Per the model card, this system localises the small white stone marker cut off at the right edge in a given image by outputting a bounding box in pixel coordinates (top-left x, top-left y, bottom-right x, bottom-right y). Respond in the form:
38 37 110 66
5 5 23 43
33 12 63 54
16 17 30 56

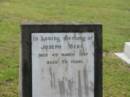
115 42 130 64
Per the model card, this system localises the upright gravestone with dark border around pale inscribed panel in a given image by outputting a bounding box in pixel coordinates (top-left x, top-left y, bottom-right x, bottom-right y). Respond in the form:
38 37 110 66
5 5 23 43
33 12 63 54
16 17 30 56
21 24 102 97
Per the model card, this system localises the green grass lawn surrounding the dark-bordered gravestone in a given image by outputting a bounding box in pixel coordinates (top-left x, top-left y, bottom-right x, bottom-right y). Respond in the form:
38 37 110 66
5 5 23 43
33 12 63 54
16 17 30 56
0 0 130 97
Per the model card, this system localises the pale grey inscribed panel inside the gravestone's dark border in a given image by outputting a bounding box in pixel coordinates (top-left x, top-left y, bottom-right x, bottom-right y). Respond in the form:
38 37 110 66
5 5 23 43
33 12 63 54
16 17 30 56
31 32 94 97
